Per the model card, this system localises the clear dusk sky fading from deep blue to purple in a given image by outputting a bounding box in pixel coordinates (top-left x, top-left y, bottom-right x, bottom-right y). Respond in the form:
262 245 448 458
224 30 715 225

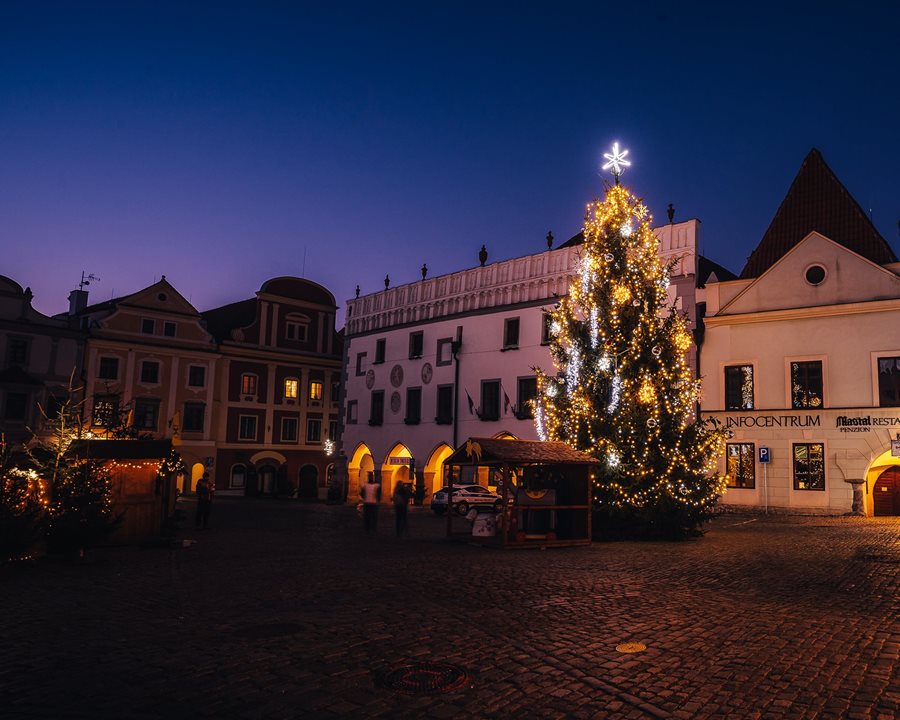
0 0 900 324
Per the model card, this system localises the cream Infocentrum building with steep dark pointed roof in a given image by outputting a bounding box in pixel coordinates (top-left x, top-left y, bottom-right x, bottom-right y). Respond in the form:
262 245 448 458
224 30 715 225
700 150 900 516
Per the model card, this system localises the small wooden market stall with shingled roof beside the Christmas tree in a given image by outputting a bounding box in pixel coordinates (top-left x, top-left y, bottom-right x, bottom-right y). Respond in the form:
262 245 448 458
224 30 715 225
444 438 599 548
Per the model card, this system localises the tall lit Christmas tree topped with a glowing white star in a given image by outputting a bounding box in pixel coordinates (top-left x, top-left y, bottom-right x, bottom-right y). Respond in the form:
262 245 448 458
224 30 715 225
535 146 725 537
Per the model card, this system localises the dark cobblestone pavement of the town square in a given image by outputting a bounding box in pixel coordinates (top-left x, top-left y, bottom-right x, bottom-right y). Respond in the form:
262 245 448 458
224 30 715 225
0 499 900 720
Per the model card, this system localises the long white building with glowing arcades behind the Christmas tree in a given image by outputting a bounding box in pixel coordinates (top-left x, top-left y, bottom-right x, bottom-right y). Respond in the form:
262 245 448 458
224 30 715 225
342 220 729 502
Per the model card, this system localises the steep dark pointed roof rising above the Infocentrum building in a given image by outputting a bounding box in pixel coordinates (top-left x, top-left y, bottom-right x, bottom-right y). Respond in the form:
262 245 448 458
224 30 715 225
741 148 897 278
